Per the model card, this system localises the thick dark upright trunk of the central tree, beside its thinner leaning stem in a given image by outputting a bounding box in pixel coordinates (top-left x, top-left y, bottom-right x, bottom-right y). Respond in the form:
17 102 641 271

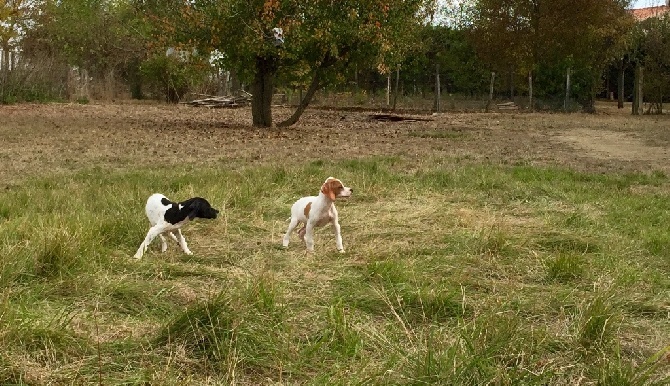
251 56 276 127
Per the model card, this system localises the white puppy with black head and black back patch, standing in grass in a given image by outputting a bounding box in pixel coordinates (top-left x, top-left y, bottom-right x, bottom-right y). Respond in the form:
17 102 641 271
135 193 219 259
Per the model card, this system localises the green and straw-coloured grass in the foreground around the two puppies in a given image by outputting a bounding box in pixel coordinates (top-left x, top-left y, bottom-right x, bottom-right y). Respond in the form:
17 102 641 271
0 159 670 385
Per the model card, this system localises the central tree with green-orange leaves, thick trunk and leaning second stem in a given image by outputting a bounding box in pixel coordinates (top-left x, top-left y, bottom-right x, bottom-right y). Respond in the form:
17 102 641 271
161 0 434 127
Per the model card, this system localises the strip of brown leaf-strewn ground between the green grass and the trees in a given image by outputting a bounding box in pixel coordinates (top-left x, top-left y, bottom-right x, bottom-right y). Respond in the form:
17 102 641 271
0 104 670 182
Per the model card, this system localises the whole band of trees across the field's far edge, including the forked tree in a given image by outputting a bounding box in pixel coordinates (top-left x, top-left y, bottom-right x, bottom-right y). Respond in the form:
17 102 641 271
0 0 670 126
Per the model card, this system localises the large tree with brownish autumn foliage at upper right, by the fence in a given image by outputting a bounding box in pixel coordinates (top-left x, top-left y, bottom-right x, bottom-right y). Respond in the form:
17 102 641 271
469 0 632 111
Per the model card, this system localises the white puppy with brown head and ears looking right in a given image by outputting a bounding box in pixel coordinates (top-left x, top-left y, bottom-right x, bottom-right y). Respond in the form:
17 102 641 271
283 177 354 252
